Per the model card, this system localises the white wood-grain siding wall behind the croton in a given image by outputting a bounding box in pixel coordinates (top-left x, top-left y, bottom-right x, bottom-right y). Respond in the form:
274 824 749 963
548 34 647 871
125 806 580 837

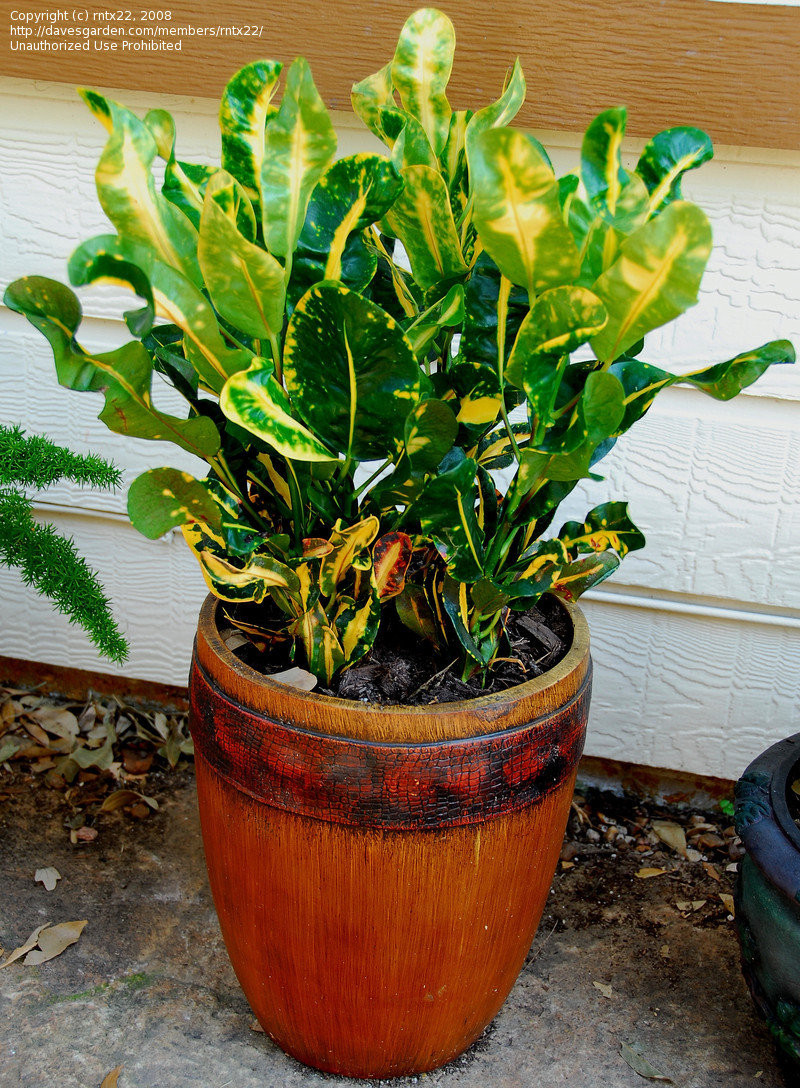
0 79 800 777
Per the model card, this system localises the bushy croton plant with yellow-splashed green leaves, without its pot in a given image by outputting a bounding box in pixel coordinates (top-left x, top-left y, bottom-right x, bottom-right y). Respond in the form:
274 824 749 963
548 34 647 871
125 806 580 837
5 9 793 681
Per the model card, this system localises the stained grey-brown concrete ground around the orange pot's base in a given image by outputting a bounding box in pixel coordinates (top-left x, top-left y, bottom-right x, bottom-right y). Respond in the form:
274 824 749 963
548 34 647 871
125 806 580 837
0 765 784 1088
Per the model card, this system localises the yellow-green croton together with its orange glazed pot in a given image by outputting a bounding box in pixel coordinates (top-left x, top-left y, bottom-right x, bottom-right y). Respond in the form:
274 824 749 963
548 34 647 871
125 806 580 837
5 9 793 1076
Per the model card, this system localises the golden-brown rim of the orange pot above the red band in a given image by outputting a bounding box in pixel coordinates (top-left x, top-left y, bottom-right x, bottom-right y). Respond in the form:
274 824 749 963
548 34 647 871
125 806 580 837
199 593 590 718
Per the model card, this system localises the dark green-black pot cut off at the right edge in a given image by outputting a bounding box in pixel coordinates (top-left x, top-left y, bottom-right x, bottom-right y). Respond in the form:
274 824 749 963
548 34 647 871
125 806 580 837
736 733 800 1072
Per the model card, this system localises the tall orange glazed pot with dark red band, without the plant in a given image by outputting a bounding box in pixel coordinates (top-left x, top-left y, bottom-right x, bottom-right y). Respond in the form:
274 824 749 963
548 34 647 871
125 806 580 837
190 597 591 1077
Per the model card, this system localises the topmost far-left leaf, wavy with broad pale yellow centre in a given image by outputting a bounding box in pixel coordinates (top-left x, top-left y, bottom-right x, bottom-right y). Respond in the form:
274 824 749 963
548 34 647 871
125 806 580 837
78 88 201 284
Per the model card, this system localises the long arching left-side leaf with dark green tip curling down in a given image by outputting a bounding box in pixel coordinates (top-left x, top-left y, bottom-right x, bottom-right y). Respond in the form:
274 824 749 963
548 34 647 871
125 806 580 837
69 235 253 393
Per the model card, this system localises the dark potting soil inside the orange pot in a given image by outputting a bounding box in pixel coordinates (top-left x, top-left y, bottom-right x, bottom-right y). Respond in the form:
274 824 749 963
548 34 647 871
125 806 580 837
226 596 571 706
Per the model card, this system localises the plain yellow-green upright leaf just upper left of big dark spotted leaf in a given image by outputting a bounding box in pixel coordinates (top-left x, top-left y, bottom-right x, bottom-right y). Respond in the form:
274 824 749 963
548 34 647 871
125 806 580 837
197 170 285 344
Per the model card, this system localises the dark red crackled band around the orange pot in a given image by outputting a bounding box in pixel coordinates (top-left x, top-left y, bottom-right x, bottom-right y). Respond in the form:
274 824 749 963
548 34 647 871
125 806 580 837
189 662 591 829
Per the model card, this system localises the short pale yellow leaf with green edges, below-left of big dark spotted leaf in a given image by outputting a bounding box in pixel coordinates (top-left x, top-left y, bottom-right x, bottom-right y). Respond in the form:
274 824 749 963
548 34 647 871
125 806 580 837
220 358 336 461
